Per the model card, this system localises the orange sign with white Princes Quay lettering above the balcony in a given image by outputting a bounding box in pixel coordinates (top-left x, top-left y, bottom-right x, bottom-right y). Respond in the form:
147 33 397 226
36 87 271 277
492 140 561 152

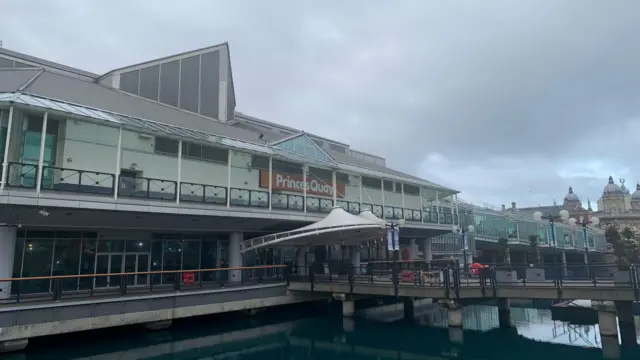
260 170 347 198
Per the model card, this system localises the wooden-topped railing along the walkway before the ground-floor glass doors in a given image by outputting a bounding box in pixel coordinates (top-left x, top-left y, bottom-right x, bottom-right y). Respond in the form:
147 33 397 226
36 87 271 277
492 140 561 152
0 265 291 304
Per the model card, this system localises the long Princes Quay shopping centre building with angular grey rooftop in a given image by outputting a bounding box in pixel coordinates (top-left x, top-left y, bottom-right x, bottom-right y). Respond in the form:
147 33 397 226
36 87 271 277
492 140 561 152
0 44 604 297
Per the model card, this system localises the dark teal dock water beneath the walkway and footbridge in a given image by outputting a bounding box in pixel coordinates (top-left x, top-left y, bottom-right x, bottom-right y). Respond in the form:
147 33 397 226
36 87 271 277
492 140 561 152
0 306 640 360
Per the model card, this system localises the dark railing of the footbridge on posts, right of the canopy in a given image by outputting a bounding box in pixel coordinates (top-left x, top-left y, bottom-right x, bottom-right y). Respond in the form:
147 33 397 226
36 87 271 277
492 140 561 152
291 261 640 301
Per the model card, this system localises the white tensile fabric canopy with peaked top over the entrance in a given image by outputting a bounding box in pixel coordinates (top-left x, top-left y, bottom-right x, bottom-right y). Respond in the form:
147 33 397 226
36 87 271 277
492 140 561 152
242 206 385 252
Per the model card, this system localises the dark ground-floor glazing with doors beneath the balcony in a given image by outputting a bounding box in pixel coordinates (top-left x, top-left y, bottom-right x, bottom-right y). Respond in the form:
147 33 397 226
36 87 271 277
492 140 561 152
12 230 295 294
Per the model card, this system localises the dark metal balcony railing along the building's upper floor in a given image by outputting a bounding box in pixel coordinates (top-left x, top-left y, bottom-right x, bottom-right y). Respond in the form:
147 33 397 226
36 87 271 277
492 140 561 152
6 162 457 224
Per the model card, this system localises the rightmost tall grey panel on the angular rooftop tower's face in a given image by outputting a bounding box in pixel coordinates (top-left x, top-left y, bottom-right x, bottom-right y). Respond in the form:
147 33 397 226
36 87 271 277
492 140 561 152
200 51 220 120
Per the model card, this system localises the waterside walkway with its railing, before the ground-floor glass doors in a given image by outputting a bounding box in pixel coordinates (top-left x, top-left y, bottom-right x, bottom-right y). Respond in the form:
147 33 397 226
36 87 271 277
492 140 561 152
0 265 328 352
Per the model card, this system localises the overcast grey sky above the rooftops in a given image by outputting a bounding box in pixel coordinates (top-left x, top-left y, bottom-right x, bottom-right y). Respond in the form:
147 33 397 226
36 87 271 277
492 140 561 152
0 0 640 205
